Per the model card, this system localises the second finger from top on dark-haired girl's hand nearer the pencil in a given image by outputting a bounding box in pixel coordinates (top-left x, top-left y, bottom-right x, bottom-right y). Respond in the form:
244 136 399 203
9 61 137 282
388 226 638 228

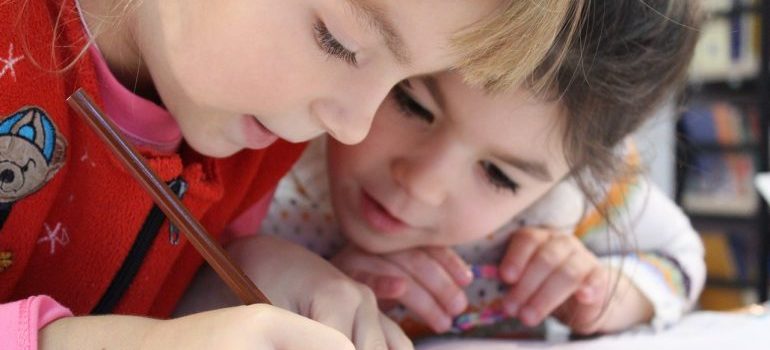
391 250 468 315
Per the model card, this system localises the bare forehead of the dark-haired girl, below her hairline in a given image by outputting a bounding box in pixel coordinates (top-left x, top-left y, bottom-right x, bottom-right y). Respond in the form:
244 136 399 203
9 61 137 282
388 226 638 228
434 72 566 171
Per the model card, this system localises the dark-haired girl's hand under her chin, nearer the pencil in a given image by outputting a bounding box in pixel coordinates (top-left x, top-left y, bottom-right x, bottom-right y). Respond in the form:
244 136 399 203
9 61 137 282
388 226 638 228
332 245 472 333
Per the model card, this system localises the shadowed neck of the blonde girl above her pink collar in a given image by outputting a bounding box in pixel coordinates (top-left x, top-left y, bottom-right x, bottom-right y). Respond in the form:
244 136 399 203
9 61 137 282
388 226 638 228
78 0 160 102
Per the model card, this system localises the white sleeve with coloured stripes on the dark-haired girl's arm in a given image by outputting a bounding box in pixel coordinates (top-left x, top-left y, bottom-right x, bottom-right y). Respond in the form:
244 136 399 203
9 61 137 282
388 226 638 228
583 176 706 329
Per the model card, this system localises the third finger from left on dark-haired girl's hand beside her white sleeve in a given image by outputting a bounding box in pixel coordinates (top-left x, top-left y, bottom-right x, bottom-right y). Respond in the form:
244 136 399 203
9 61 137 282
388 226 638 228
519 249 596 326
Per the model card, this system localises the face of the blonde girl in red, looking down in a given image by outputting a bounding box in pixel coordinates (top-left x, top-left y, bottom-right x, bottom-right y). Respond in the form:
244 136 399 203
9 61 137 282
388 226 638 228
138 0 499 156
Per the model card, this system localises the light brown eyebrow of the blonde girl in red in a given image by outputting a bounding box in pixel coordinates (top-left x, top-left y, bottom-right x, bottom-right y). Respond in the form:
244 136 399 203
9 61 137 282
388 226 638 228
347 0 411 65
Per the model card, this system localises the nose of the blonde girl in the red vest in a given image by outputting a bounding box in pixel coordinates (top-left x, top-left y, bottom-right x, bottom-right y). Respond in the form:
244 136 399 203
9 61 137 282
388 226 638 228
310 81 393 145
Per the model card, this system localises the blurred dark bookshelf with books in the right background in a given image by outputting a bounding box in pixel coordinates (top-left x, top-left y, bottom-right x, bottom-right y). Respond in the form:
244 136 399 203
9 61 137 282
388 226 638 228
675 0 770 301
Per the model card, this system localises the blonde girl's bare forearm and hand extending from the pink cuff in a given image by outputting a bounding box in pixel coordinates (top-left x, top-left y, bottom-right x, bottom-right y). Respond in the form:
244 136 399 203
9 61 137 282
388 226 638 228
39 305 354 350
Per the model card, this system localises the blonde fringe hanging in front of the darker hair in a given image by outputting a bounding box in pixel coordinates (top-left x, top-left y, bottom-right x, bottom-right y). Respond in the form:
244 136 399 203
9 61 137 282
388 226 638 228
453 0 586 92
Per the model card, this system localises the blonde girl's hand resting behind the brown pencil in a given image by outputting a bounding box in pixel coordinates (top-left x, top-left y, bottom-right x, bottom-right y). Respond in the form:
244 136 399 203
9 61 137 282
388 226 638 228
228 236 413 350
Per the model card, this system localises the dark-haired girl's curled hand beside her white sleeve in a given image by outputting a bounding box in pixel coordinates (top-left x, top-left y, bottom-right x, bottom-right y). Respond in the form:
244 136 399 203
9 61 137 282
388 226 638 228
500 228 609 330
